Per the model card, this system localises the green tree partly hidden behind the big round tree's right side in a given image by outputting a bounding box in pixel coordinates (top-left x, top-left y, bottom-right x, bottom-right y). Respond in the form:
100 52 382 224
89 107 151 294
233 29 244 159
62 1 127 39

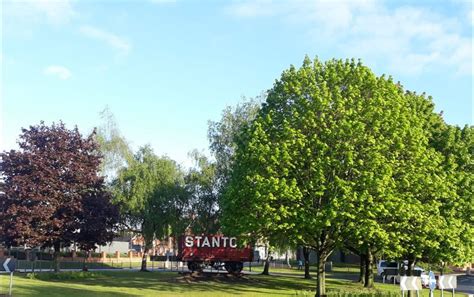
344 91 460 287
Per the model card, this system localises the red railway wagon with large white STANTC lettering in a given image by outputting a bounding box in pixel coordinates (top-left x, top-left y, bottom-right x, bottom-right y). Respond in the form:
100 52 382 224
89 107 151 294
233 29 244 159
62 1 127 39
178 235 253 273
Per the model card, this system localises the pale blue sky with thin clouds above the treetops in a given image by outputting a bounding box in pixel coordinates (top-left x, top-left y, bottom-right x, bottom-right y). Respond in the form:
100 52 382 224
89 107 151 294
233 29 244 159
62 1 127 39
0 0 474 165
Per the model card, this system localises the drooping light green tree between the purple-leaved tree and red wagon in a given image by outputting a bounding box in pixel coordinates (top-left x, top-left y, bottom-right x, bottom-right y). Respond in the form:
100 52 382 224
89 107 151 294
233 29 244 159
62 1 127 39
112 146 187 271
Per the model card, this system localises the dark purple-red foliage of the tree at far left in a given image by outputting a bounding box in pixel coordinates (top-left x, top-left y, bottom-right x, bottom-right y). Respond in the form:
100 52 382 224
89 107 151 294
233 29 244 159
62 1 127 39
0 122 119 249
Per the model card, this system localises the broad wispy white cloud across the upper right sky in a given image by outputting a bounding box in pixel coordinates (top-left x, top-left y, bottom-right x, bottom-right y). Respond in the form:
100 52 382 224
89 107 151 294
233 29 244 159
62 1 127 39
226 0 473 75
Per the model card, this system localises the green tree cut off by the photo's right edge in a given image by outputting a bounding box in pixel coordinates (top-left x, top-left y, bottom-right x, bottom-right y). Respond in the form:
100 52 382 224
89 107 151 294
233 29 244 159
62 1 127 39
414 104 474 267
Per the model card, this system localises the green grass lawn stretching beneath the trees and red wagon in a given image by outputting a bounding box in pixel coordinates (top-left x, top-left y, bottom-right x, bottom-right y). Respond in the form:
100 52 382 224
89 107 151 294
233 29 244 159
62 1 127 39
0 269 465 297
